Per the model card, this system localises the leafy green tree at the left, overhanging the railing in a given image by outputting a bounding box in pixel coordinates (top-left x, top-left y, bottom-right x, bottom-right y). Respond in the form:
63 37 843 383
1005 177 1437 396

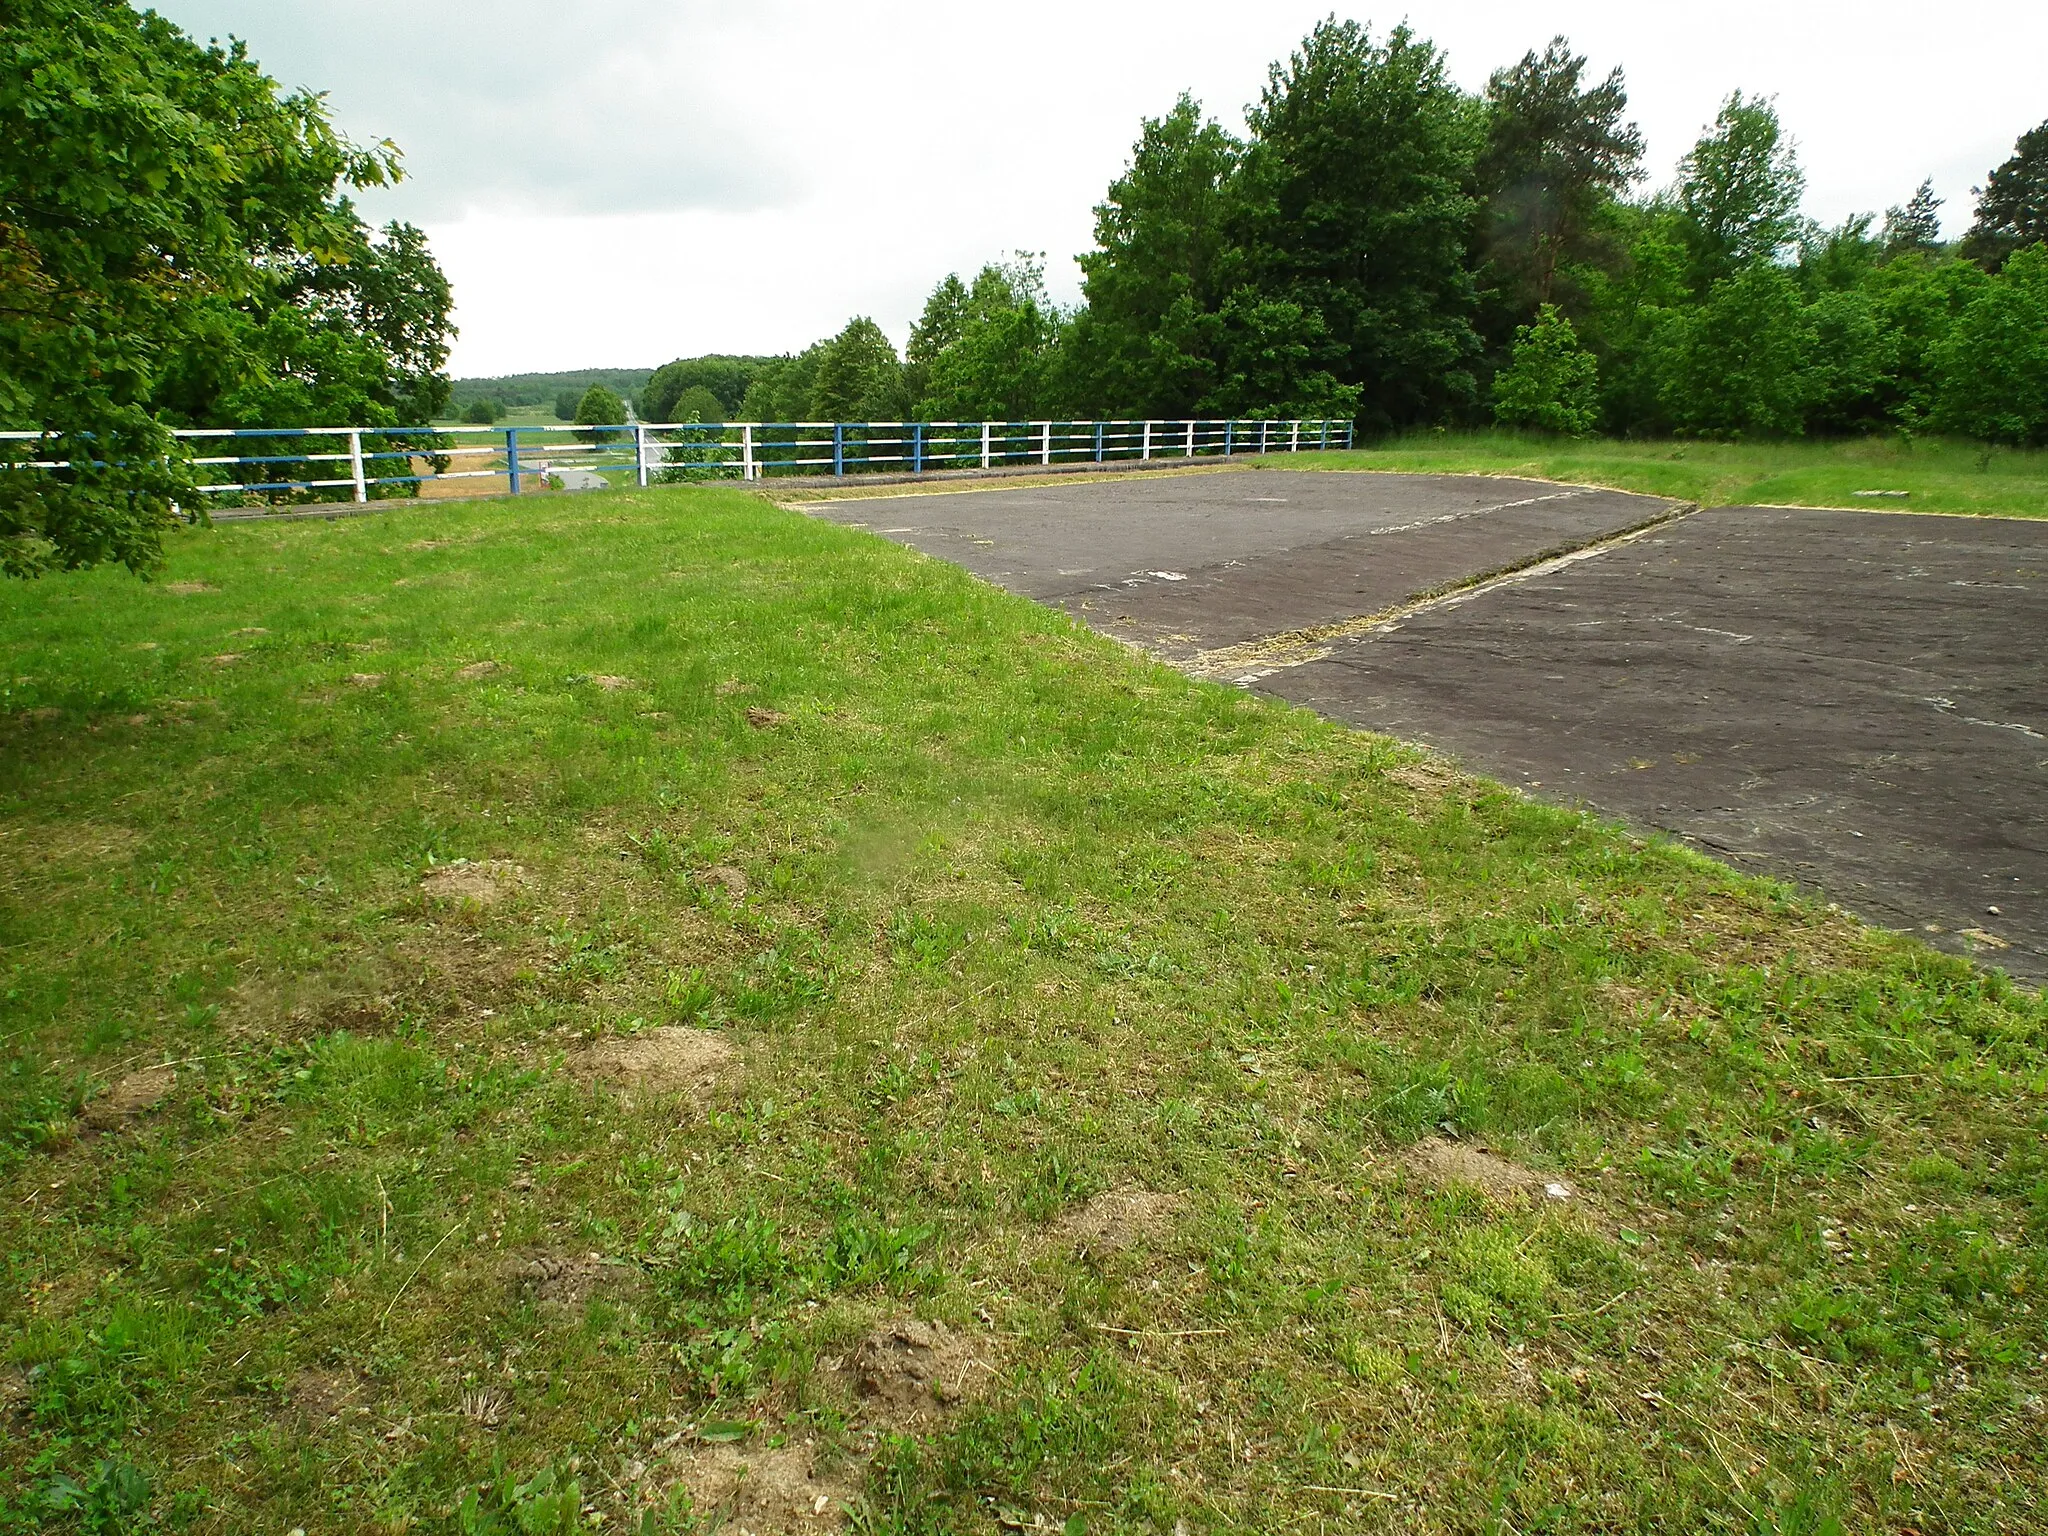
0 0 451 575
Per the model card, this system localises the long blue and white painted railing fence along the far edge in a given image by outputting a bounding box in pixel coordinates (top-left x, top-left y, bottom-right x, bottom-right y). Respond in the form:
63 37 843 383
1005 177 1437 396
0 420 1352 506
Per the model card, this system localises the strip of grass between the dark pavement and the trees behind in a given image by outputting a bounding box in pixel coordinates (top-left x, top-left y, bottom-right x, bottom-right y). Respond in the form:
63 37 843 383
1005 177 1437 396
1276 432 2048 518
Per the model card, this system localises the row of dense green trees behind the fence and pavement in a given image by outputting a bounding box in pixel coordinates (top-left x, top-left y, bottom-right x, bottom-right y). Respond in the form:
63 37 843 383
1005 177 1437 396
641 20 2048 444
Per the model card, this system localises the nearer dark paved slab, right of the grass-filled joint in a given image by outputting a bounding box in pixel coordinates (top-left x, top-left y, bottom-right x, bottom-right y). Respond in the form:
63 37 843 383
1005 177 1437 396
1260 508 2048 981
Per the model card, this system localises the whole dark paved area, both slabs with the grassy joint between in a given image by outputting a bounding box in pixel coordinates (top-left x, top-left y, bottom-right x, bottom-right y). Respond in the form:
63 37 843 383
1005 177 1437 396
805 469 2048 983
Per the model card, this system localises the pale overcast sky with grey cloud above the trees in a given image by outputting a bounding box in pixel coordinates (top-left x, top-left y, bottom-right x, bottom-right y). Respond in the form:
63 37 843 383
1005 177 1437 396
156 0 2048 375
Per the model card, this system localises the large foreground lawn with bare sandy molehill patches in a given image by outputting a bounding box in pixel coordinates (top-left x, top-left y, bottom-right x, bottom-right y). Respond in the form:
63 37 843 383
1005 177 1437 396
0 483 2048 1536
